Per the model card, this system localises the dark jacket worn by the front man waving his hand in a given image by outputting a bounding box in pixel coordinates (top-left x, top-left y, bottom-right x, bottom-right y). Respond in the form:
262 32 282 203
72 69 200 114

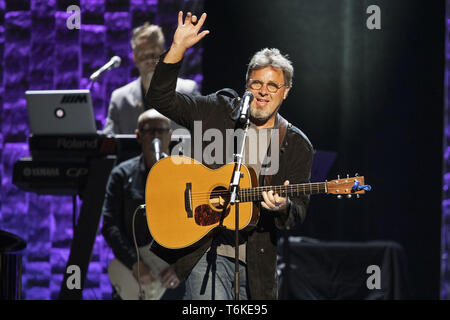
145 55 313 299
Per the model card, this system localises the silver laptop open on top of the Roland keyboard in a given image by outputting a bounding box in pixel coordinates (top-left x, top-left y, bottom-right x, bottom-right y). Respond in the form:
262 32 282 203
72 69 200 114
25 90 97 135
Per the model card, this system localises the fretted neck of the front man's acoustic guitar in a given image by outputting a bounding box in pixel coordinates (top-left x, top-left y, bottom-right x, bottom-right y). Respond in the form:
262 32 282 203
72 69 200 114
239 182 328 202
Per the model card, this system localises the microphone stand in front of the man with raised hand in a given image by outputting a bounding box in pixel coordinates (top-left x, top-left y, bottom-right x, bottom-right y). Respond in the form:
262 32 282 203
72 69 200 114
230 117 250 300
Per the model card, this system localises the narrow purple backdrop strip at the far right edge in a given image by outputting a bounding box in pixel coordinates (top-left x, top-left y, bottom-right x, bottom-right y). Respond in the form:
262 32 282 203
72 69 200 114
441 0 450 300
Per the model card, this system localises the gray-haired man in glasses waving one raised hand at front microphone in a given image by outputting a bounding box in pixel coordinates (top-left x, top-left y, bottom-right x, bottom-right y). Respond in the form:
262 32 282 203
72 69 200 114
145 12 313 300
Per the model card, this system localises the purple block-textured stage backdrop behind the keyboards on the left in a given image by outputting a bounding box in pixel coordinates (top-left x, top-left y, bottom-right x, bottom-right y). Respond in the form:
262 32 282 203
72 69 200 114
0 0 203 299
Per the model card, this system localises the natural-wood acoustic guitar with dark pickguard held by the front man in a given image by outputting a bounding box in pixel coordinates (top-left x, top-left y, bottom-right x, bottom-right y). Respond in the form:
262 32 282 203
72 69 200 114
145 156 370 249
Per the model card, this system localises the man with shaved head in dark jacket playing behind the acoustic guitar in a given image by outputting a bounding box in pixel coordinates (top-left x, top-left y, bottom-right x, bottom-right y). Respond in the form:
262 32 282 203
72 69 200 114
102 109 180 299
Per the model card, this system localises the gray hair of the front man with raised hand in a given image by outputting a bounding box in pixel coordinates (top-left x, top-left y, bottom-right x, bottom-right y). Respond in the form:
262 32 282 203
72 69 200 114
245 48 294 88
